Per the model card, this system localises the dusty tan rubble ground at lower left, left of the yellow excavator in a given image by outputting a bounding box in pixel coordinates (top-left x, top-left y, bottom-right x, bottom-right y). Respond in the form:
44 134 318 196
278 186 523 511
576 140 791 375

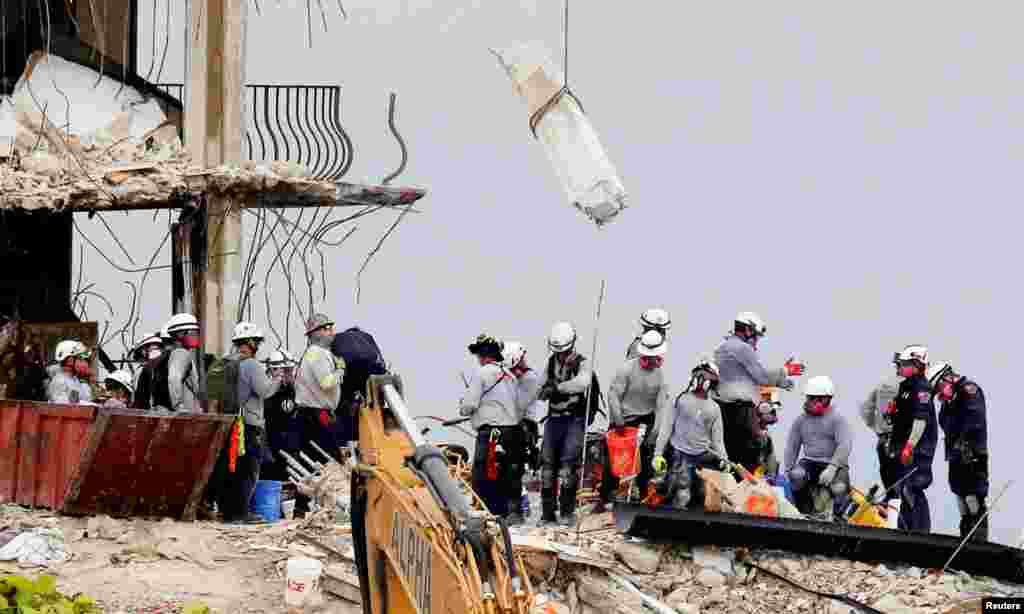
0 506 359 614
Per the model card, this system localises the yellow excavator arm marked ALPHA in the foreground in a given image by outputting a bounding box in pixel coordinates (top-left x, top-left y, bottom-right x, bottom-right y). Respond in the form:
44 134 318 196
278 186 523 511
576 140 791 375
351 375 535 614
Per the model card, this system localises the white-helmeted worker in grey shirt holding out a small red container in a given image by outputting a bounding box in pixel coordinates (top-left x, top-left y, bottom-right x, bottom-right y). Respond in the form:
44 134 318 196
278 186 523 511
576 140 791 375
714 311 804 470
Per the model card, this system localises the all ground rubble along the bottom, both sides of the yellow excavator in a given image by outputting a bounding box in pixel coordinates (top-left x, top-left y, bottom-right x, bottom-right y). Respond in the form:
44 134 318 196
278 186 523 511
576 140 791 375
0 493 1024 614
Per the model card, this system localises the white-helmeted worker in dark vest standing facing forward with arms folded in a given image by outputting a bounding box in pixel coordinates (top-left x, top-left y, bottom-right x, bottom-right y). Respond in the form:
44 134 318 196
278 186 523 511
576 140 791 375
539 322 599 526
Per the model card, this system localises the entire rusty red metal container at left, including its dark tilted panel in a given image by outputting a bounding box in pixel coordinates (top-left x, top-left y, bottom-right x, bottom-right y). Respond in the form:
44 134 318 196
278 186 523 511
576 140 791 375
0 401 233 520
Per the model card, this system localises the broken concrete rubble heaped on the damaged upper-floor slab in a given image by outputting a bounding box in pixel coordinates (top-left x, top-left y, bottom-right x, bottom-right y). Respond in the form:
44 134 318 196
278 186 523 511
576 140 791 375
0 51 337 210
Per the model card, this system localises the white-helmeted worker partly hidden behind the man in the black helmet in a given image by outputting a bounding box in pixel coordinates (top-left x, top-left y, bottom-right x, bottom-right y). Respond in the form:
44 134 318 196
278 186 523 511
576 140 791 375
502 341 544 525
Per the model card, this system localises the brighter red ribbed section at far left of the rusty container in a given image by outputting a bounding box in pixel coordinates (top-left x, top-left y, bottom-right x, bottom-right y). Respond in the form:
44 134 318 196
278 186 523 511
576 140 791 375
0 400 97 510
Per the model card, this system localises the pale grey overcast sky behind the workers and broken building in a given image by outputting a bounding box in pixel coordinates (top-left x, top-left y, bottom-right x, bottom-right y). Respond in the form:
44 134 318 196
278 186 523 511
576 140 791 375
76 0 1024 540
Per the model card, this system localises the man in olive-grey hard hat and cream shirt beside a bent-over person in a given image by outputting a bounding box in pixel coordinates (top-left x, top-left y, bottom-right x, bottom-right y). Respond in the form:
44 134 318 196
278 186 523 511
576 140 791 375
295 313 345 462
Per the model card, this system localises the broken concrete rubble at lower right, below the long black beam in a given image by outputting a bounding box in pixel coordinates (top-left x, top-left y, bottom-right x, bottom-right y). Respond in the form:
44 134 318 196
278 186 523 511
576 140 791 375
513 518 1024 614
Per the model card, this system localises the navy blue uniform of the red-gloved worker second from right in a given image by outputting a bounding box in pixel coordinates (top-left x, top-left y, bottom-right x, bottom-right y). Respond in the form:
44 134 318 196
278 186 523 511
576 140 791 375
892 375 939 533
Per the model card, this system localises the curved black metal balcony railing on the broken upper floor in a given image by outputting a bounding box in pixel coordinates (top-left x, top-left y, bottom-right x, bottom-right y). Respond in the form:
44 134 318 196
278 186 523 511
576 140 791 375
157 83 352 181
